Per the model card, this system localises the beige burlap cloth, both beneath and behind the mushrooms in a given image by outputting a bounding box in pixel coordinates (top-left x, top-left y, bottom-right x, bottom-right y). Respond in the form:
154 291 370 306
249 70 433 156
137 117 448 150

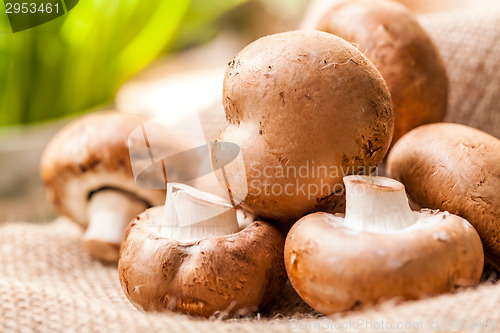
0 4 500 333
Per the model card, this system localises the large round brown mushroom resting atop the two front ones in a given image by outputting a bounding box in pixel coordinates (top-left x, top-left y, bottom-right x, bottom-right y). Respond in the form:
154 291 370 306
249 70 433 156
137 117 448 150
217 31 393 222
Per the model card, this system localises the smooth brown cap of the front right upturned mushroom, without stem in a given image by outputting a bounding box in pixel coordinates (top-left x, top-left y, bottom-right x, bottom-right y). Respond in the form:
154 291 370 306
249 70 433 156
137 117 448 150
285 212 483 315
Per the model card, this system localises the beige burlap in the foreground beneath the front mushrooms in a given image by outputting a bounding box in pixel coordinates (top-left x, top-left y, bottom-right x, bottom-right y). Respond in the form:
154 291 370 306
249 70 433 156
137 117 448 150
0 218 500 333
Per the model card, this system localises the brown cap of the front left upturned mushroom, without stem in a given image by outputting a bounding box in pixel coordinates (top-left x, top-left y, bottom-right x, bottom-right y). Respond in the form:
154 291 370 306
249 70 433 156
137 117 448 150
118 206 286 317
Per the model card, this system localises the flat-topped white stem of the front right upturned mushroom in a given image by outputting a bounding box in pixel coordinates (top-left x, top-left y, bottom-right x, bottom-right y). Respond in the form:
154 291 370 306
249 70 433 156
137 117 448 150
344 176 418 233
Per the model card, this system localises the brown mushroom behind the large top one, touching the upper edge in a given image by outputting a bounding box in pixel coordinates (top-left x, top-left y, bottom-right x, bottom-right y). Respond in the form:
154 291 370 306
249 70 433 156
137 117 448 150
317 0 448 142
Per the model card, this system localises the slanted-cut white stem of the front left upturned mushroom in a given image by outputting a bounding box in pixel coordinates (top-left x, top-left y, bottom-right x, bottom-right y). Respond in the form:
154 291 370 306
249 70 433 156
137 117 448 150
160 183 240 242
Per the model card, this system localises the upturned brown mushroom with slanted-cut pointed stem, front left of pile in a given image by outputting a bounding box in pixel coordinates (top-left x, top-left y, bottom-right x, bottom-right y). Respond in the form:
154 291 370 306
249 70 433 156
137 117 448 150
118 183 286 317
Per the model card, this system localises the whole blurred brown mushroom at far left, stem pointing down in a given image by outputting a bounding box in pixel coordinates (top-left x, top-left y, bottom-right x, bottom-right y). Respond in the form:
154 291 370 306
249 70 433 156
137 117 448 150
40 112 165 262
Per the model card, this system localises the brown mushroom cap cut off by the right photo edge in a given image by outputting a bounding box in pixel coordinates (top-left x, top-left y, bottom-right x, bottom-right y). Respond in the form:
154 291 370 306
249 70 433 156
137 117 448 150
387 123 500 266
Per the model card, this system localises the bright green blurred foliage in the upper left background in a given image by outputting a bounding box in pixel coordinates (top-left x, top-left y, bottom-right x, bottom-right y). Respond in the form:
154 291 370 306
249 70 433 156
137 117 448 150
0 0 245 126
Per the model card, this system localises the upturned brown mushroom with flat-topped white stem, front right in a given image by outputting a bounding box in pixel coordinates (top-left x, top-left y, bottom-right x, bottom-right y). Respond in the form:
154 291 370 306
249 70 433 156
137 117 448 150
285 176 483 315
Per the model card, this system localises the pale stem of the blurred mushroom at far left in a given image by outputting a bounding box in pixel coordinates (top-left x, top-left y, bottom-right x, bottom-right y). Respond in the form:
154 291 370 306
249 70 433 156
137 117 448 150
83 189 148 262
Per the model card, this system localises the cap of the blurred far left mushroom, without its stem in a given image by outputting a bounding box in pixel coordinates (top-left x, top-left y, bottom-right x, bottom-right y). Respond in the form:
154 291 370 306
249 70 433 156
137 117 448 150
40 111 165 225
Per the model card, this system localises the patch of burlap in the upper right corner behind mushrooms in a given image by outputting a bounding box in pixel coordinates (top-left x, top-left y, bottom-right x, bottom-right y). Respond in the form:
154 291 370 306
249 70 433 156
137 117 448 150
420 1 500 138
